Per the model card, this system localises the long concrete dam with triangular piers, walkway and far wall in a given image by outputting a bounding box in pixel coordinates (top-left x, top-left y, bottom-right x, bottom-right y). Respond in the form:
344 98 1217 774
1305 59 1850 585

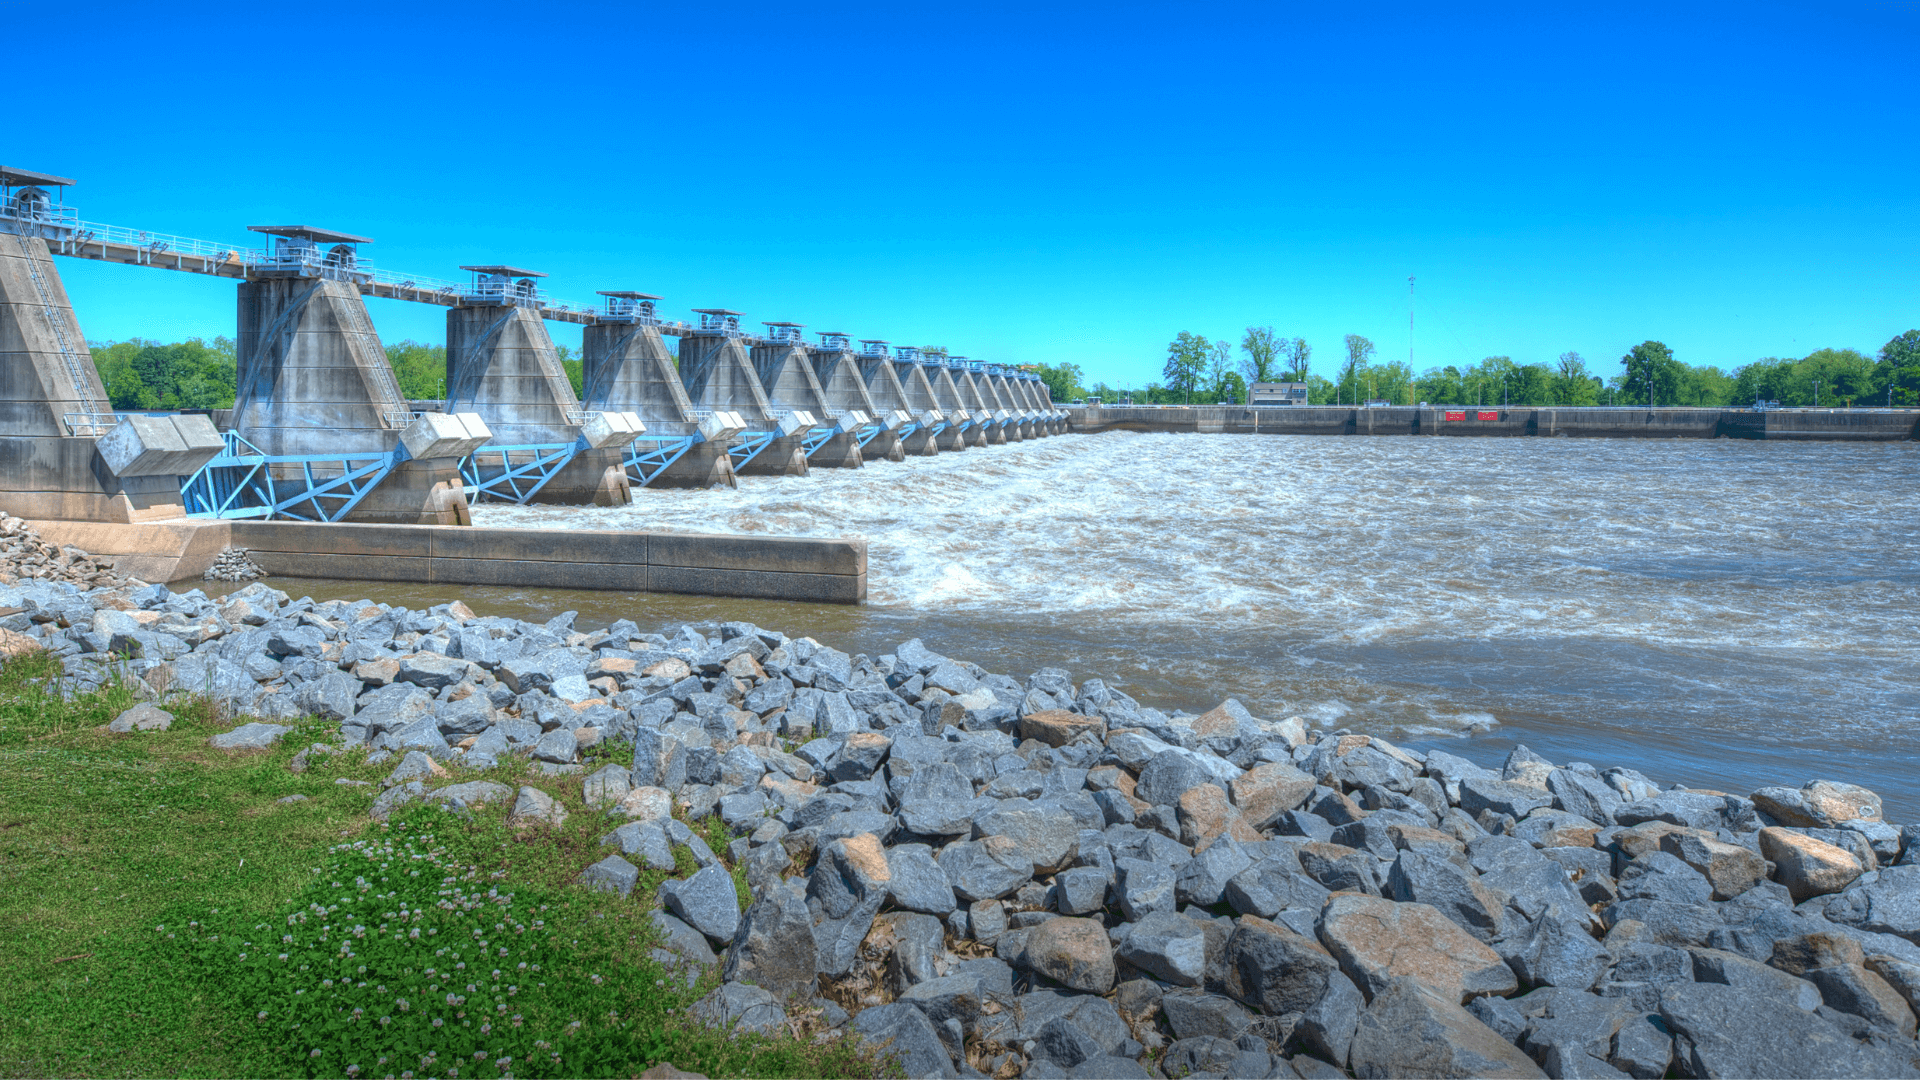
0 167 1920 601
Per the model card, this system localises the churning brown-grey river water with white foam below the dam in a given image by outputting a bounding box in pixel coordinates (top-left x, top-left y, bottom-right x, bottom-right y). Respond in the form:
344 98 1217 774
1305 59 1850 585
432 432 1920 807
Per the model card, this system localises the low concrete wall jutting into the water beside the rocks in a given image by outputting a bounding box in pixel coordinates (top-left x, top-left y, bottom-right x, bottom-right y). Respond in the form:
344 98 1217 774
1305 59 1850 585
33 521 866 603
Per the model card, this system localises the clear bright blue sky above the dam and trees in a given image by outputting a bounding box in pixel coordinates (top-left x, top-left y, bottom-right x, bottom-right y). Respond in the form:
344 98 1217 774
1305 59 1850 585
18 2 1920 384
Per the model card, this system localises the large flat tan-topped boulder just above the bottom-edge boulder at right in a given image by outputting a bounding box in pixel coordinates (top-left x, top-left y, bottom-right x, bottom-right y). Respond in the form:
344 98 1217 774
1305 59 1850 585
1319 894 1519 1001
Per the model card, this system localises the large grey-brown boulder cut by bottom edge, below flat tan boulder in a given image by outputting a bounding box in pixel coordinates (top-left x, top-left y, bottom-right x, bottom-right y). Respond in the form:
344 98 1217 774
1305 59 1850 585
1350 978 1546 1078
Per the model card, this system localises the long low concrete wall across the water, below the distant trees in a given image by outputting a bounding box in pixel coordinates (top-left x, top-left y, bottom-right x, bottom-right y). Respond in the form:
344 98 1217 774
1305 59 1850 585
1066 405 1920 442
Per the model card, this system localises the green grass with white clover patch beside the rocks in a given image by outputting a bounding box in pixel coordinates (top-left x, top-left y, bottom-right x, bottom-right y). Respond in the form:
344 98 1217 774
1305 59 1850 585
0 655 883 1078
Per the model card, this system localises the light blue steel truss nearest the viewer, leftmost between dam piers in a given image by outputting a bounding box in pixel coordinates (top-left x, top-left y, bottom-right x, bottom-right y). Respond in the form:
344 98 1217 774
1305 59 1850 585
180 430 407 521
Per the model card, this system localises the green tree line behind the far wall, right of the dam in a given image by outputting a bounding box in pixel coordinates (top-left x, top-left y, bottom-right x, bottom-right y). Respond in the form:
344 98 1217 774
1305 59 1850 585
1041 327 1920 407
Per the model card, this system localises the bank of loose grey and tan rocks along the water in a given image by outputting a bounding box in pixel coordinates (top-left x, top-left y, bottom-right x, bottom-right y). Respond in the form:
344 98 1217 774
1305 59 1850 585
0 530 1920 1078
